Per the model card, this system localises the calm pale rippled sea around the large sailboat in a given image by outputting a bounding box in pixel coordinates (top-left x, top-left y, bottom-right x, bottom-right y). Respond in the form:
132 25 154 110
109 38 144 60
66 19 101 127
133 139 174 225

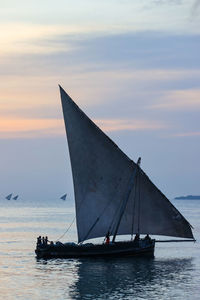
0 200 200 300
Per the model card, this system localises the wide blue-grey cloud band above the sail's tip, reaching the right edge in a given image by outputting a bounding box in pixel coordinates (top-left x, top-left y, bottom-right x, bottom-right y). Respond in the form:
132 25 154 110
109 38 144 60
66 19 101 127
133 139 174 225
46 31 200 70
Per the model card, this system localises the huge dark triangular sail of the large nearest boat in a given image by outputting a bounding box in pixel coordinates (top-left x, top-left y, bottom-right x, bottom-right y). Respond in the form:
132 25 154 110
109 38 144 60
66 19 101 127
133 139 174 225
60 87 193 242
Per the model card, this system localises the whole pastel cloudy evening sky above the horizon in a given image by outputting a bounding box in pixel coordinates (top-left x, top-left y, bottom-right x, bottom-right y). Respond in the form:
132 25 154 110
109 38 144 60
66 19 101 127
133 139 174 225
0 0 200 201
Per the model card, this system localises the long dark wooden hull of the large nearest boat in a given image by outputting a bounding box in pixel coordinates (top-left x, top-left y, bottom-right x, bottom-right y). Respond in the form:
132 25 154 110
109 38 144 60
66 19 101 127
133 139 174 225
35 239 155 258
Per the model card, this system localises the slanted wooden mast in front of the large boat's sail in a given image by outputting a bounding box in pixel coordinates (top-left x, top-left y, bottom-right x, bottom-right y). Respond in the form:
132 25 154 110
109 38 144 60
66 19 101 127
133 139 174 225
112 157 141 243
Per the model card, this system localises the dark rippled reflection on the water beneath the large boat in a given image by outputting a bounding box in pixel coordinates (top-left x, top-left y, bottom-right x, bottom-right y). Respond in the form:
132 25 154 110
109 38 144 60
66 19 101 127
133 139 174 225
38 258 193 299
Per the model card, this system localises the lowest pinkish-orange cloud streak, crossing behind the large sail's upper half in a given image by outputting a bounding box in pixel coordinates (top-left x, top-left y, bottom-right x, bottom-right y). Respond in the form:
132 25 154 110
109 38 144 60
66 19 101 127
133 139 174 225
0 119 166 138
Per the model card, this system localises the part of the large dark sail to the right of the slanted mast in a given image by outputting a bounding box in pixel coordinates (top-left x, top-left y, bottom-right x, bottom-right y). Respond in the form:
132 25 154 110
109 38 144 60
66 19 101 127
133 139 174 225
115 170 194 238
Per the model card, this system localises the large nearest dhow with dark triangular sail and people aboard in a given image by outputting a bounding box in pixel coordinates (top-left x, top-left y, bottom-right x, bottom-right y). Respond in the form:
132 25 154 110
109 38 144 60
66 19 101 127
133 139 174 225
35 87 194 258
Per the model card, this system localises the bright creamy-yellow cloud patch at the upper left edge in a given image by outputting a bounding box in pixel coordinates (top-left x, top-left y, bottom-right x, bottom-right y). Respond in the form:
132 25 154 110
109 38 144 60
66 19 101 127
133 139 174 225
0 23 92 56
